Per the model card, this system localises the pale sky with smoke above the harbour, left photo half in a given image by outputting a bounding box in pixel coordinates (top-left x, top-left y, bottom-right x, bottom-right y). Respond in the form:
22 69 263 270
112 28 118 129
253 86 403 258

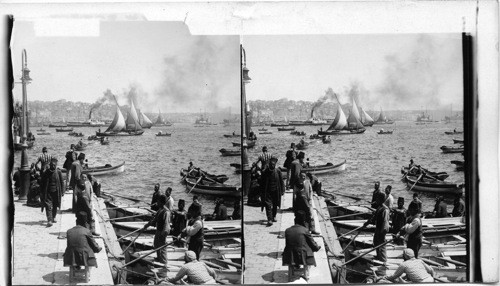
11 21 240 113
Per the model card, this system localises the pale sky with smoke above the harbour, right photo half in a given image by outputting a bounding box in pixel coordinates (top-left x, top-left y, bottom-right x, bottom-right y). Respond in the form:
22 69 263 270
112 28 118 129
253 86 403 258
241 34 463 111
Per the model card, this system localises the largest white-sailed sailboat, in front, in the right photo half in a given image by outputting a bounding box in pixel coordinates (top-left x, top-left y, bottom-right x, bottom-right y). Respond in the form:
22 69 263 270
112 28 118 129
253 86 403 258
318 94 366 135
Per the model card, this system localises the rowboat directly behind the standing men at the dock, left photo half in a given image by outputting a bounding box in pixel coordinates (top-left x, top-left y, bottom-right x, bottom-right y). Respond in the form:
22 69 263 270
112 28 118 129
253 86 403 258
112 220 241 238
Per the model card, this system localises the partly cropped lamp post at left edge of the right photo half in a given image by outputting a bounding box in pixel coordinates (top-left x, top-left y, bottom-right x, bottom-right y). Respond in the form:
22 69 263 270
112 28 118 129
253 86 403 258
240 45 252 196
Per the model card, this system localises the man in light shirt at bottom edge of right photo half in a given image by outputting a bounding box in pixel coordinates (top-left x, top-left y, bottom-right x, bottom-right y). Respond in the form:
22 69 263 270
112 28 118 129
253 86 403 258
384 248 434 283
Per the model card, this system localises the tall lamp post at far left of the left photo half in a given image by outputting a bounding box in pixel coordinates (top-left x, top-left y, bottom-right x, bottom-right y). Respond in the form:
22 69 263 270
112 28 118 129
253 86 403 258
19 49 31 201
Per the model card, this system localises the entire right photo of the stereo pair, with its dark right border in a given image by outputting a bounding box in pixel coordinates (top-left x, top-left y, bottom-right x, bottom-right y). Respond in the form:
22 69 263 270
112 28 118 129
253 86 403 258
241 33 473 284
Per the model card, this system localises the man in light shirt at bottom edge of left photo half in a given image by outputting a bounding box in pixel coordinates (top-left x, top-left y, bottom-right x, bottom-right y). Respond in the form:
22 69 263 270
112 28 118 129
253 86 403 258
168 250 216 285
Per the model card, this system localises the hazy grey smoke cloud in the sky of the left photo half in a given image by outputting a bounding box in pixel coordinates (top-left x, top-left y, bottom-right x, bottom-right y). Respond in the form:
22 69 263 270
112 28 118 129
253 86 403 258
155 36 240 112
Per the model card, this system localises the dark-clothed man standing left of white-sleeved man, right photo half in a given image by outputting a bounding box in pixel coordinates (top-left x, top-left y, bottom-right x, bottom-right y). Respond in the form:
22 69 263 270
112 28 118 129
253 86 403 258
363 192 389 262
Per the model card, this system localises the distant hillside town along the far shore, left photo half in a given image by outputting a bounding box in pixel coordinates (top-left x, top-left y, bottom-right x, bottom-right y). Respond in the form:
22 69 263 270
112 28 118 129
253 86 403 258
14 99 240 126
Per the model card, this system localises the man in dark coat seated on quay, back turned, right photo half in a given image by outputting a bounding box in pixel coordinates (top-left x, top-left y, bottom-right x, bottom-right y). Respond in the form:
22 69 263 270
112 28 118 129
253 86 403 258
283 211 321 282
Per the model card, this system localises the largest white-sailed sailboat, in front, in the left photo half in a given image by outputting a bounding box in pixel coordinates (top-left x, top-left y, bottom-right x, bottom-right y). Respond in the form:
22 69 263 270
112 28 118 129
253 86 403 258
96 98 144 137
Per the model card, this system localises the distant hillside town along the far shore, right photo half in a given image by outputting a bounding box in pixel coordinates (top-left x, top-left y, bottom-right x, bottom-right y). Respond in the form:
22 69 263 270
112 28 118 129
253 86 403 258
248 98 463 123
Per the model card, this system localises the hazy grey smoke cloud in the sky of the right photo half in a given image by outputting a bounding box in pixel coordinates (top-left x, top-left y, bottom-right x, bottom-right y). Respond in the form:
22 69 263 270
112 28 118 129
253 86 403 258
374 35 462 109
